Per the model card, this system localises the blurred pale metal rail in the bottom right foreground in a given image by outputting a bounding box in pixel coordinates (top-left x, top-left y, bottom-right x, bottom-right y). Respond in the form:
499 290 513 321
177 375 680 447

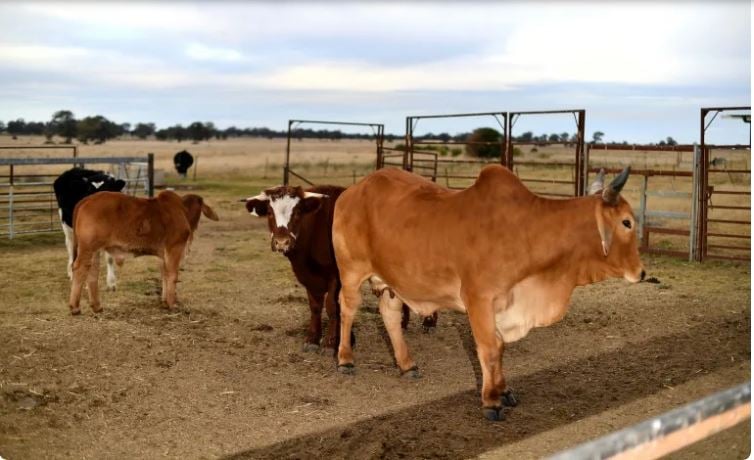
549 382 751 460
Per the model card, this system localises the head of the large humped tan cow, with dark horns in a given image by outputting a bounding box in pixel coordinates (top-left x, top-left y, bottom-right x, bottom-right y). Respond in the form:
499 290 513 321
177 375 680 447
589 167 645 283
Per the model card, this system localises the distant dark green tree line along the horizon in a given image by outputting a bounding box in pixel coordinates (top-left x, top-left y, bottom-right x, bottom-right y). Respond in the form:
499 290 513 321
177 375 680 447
0 110 677 145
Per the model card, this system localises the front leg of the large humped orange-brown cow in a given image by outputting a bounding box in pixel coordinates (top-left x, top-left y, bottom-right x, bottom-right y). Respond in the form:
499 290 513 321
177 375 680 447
465 299 505 421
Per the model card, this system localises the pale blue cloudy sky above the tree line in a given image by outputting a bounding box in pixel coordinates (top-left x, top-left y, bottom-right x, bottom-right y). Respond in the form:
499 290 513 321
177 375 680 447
0 1 752 143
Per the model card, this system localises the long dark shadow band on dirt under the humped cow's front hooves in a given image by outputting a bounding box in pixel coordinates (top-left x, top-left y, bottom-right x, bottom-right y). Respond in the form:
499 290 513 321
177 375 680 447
226 314 750 459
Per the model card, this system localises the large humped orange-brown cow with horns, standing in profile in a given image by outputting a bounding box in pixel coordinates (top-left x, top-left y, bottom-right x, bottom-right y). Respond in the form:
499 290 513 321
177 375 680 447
333 165 644 420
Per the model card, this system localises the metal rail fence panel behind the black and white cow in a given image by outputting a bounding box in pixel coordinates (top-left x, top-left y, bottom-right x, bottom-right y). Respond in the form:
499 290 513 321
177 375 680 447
0 153 154 239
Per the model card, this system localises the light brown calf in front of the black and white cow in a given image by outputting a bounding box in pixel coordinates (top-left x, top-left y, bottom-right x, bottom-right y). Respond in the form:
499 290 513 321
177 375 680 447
69 191 218 315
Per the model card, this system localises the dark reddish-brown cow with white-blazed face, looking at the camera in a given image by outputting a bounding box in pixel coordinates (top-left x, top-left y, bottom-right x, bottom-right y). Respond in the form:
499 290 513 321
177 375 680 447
244 185 345 351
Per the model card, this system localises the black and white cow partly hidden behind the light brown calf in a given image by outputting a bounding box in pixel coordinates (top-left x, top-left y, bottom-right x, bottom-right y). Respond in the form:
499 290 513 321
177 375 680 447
52 168 126 289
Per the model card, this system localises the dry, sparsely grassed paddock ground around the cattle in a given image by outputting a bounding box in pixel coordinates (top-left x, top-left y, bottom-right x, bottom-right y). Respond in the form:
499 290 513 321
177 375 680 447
0 135 751 459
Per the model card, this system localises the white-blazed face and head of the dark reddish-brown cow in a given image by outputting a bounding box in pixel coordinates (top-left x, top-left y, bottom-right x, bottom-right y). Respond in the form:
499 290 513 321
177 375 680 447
246 185 327 253
